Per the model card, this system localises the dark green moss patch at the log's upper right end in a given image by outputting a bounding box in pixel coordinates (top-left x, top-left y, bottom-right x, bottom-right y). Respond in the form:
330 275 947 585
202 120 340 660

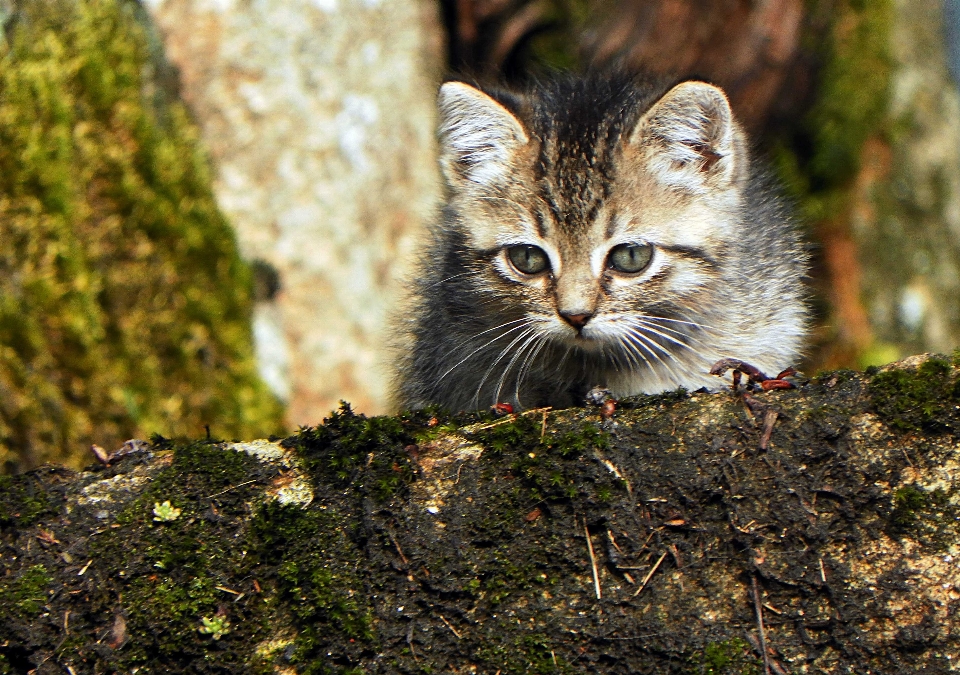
869 357 960 432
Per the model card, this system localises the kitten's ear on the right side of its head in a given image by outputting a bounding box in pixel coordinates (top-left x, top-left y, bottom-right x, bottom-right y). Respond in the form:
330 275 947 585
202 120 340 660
630 82 741 193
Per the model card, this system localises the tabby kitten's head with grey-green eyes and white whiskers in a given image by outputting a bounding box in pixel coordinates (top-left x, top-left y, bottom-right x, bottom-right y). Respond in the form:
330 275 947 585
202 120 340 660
439 74 748 364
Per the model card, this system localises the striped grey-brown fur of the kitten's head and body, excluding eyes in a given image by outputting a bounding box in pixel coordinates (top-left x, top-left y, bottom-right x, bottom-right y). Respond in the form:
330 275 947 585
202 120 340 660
398 76 807 410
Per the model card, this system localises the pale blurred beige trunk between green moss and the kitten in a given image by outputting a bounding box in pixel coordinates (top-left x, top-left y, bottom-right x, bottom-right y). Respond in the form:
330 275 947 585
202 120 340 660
146 0 442 426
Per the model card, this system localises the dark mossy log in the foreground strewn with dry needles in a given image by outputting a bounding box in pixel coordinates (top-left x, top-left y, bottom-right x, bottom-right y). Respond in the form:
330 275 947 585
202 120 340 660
0 354 960 675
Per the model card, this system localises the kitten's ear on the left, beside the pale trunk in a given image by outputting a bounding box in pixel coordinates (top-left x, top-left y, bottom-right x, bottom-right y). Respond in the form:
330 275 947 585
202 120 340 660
437 82 528 186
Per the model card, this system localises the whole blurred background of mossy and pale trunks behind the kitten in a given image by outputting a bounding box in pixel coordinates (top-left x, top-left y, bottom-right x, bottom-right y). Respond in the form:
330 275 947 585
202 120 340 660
0 0 960 473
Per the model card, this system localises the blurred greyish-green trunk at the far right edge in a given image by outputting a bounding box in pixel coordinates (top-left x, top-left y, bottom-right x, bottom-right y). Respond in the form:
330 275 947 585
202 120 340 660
851 0 960 364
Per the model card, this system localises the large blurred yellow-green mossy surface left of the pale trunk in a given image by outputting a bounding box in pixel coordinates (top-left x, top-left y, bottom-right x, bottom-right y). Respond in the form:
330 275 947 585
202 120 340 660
0 0 282 471
